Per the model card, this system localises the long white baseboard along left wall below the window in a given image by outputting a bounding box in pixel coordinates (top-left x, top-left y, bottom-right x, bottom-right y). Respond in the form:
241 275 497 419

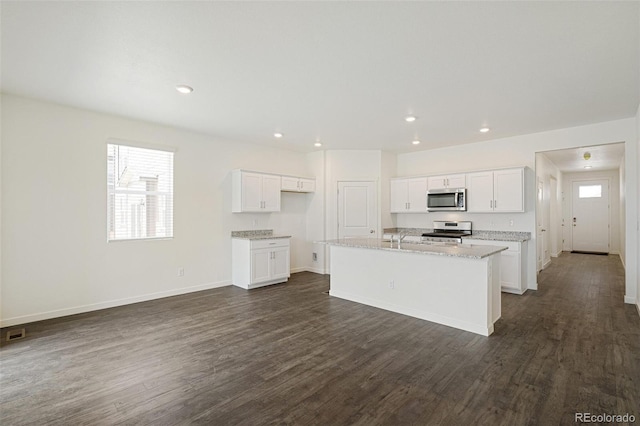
0 281 231 327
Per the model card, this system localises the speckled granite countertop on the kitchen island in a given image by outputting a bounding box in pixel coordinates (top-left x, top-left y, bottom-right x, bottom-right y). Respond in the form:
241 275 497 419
322 238 507 259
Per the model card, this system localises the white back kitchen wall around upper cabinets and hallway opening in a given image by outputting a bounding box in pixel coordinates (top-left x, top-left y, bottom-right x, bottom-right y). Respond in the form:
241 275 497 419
397 118 640 303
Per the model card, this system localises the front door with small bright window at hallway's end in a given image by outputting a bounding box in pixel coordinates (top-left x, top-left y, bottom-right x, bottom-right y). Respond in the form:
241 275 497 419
571 179 609 253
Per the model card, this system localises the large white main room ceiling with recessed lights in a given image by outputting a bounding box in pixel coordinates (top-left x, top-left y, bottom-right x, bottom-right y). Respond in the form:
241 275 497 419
0 1 640 152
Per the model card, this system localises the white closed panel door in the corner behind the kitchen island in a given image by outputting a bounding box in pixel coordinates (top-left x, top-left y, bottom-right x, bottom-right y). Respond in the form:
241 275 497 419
338 181 378 238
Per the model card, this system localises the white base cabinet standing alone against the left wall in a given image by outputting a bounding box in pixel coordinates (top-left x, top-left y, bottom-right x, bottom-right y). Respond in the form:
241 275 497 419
231 238 291 289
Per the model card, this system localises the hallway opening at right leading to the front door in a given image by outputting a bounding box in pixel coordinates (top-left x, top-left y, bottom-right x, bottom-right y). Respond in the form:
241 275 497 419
535 143 625 272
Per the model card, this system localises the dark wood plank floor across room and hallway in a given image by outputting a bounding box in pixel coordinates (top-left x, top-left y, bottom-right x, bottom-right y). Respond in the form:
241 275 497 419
0 254 640 425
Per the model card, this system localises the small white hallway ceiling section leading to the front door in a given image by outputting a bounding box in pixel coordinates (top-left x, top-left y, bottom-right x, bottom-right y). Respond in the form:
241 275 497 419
544 143 624 172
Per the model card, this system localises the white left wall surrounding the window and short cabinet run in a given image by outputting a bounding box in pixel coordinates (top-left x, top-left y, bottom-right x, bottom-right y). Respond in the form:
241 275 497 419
0 95 312 326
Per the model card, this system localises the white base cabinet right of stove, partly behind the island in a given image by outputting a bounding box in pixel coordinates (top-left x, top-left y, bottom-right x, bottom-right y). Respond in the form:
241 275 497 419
463 238 527 294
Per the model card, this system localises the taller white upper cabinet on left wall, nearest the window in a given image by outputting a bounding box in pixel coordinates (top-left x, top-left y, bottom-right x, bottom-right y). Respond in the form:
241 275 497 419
231 170 281 213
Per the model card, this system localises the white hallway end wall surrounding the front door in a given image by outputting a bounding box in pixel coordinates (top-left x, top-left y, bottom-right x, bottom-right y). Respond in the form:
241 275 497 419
562 170 621 254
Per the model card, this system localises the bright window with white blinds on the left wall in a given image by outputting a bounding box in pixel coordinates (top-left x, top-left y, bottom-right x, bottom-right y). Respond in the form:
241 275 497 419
107 144 173 241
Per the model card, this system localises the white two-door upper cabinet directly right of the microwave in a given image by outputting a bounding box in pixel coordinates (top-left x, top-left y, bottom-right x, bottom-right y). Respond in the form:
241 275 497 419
467 168 524 213
